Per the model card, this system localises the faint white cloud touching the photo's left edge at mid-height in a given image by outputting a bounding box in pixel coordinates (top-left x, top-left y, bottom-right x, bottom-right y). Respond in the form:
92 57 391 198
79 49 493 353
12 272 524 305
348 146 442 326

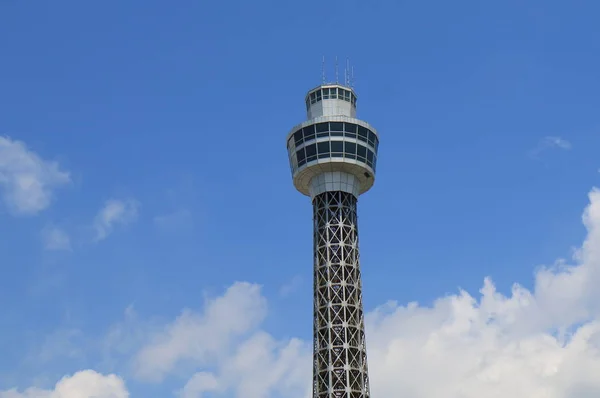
0 137 71 215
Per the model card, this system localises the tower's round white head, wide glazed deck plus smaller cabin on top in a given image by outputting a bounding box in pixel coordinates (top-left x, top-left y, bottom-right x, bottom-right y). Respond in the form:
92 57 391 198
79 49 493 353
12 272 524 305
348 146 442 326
286 84 379 198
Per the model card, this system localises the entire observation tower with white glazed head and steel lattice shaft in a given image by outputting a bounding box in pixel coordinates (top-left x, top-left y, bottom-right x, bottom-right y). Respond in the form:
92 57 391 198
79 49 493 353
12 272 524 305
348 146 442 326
287 84 379 398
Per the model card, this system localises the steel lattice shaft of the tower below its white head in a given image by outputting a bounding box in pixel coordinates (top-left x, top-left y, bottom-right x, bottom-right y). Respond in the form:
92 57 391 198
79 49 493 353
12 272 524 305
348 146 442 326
313 191 370 398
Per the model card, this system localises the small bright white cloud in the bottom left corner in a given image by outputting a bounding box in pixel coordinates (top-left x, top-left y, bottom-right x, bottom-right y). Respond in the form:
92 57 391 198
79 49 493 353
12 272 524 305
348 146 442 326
0 370 129 398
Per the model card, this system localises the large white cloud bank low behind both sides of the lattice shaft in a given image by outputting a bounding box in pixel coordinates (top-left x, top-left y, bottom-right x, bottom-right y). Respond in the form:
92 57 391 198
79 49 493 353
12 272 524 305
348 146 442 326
0 189 600 398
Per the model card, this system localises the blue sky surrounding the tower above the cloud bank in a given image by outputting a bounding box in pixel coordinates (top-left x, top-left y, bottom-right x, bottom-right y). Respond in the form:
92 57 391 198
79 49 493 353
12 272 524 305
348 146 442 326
0 0 600 398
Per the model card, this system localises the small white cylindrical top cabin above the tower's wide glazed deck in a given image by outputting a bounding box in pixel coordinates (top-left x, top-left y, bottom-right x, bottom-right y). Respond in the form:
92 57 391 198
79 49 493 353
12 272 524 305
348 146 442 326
306 84 356 120
